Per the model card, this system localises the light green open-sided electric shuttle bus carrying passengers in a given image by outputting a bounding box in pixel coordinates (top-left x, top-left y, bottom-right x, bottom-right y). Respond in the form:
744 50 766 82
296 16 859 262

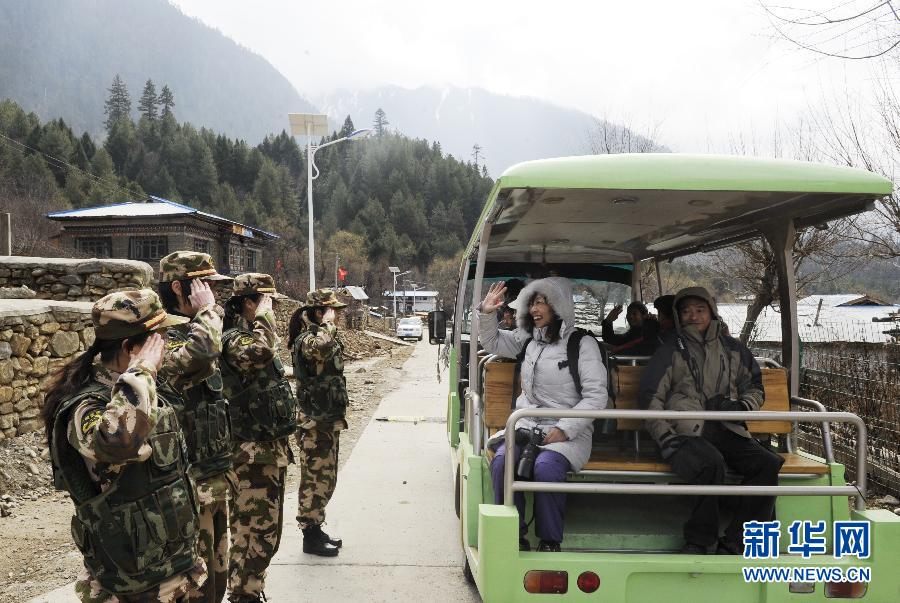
429 154 900 603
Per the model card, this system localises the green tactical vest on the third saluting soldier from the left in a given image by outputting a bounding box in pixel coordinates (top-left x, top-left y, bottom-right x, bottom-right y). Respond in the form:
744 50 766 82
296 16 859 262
221 329 297 442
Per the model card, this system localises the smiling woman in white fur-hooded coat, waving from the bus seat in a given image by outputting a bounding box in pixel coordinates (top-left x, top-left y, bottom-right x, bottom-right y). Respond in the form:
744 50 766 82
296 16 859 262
478 277 607 551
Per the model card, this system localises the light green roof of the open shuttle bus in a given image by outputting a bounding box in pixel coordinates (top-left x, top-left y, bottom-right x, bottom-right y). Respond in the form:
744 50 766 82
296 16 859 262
469 153 893 266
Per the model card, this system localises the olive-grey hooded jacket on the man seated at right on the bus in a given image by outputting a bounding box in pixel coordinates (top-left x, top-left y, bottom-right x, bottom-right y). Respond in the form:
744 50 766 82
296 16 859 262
638 287 765 442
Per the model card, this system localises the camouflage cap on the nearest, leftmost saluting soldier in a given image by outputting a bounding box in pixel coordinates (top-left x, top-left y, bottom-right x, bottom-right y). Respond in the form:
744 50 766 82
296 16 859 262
91 289 190 339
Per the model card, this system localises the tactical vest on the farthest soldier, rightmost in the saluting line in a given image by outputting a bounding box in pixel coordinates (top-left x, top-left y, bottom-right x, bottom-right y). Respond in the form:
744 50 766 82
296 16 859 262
291 328 349 423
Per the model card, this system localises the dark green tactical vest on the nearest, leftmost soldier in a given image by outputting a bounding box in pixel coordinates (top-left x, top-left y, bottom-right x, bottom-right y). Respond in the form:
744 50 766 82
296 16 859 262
50 383 198 594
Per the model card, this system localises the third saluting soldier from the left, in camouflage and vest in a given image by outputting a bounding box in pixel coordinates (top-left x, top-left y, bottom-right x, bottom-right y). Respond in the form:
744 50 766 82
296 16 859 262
221 273 297 603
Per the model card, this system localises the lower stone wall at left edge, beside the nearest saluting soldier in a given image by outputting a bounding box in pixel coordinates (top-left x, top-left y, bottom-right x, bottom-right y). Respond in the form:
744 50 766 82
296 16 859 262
0 299 94 440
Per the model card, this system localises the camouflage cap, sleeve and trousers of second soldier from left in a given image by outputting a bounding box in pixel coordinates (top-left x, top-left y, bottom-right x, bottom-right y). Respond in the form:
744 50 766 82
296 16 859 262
159 251 237 603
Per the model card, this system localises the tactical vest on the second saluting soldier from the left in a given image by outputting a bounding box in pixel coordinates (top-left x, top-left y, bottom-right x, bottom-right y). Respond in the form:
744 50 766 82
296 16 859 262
165 329 231 480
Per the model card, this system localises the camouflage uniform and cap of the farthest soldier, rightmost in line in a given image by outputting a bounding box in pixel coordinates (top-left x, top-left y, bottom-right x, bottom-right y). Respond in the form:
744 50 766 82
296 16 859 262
292 289 347 547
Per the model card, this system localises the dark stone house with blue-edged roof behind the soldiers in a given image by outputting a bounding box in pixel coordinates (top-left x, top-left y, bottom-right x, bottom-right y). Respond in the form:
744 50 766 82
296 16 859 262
47 196 278 274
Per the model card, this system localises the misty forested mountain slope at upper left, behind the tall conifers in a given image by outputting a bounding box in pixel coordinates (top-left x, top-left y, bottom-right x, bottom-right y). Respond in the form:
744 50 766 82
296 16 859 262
0 0 313 142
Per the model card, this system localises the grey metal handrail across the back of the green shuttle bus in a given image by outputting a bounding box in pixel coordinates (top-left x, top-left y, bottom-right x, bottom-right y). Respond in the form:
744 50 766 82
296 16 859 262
503 408 867 511
